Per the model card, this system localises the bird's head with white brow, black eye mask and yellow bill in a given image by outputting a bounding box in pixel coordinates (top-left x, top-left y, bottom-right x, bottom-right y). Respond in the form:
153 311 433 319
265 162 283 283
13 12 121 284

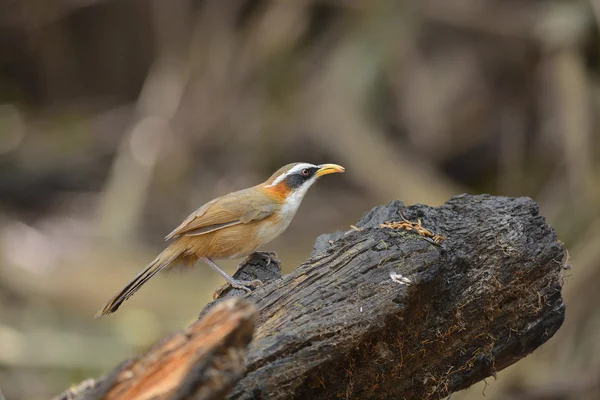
262 162 344 205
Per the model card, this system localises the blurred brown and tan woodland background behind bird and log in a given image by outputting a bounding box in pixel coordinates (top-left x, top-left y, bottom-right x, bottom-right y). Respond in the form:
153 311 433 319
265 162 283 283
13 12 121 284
0 0 600 400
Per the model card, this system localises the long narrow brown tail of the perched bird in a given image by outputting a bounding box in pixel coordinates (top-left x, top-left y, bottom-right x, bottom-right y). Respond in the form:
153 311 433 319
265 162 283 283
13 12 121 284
94 247 180 318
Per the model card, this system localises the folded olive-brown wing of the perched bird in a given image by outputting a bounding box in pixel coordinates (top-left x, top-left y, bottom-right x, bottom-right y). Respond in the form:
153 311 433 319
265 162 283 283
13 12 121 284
165 188 280 240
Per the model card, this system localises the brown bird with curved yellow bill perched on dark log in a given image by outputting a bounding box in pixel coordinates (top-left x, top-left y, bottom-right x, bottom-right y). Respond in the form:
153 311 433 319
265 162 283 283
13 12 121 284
95 162 345 318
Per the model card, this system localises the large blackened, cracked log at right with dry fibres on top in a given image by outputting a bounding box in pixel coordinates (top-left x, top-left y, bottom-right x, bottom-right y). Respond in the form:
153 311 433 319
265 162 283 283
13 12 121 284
54 195 565 399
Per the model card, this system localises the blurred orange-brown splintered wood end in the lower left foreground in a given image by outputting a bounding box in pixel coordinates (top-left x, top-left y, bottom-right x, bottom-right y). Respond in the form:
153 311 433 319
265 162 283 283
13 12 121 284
56 298 256 400
